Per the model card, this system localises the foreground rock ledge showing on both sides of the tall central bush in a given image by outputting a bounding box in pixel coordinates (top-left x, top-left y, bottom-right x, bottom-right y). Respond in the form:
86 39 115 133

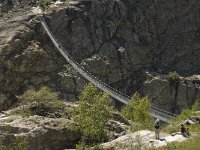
0 102 130 150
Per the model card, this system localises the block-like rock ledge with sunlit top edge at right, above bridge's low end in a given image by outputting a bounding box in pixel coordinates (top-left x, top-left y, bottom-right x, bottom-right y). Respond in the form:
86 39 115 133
143 73 200 113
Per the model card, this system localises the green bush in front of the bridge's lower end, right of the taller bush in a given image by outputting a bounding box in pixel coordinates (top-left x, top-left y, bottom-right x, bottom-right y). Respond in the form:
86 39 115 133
121 92 153 129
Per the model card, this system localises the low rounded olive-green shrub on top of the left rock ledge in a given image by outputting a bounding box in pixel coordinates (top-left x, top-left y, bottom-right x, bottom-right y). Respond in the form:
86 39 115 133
14 87 63 116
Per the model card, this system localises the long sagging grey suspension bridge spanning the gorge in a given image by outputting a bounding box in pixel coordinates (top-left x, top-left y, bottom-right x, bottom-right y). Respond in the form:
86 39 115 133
41 18 177 123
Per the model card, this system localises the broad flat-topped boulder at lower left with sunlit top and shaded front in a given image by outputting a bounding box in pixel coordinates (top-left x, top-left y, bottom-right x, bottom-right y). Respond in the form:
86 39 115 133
0 116 81 150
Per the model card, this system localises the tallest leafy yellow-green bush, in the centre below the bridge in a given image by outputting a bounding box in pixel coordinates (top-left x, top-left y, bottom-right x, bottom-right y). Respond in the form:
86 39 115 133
73 84 112 144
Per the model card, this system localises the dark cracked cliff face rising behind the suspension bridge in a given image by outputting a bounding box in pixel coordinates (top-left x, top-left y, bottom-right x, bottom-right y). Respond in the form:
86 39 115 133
0 0 200 109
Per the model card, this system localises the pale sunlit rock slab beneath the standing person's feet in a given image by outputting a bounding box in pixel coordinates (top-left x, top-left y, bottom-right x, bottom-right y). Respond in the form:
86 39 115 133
102 130 187 150
